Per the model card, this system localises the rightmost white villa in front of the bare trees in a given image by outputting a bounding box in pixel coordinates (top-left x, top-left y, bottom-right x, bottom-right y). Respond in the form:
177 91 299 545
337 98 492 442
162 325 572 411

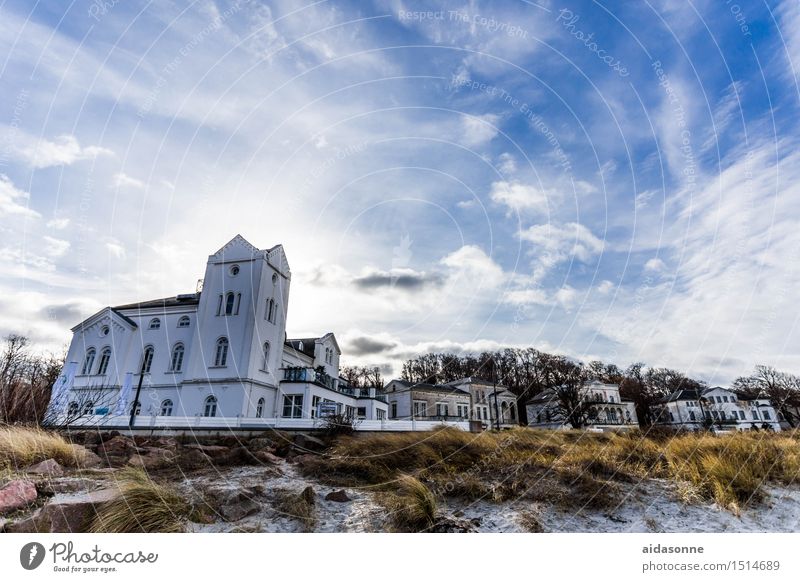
657 386 781 431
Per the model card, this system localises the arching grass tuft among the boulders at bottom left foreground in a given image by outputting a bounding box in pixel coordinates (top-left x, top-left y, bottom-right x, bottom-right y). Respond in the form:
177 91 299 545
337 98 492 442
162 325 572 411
90 468 191 533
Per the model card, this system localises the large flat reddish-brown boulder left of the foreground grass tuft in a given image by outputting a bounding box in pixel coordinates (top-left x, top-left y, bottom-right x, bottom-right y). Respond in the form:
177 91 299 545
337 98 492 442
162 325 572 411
6 489 120 533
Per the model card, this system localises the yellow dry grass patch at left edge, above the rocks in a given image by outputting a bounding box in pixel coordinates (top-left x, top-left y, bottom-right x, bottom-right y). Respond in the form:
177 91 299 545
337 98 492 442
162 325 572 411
0 426 85 469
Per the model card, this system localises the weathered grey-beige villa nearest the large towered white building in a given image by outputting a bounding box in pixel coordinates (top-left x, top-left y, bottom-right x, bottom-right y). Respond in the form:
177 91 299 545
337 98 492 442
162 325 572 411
384 378 519 428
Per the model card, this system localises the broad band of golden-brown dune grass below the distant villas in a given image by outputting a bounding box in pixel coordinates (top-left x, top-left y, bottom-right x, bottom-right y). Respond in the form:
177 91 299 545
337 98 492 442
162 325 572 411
306 428 800 511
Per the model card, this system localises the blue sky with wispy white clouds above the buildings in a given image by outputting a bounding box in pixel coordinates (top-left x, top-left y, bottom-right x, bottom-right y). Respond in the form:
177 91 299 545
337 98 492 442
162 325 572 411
0 0 800 383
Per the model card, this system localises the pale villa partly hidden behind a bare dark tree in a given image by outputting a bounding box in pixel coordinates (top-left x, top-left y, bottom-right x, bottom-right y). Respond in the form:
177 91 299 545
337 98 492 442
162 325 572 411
525 380 638 430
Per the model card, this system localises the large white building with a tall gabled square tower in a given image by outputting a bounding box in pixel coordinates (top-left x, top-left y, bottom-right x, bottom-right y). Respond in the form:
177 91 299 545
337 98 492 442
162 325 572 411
53 235 387 424
